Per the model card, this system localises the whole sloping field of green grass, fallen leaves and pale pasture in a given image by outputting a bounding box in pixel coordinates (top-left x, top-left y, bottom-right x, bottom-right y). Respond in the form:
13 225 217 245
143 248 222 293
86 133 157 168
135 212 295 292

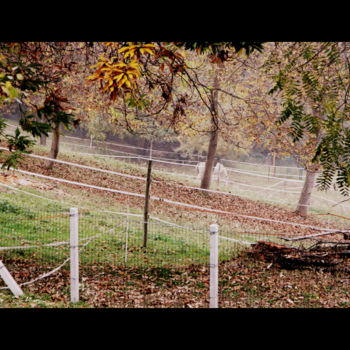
0 121 348 307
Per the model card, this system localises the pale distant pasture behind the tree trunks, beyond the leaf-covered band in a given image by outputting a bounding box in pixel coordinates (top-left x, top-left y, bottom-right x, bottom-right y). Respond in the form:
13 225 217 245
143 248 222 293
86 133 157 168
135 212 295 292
29 135 350 232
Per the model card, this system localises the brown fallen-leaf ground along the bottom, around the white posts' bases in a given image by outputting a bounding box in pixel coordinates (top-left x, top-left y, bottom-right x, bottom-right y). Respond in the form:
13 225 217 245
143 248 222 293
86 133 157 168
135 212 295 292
0 252 350 308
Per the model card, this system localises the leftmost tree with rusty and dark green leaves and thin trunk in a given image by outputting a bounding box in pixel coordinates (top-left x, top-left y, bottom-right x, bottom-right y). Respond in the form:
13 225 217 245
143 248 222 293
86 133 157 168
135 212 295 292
0 42 99 167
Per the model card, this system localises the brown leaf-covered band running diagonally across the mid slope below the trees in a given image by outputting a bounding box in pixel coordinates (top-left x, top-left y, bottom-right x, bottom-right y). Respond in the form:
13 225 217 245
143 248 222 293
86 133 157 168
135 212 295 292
0 148 339 241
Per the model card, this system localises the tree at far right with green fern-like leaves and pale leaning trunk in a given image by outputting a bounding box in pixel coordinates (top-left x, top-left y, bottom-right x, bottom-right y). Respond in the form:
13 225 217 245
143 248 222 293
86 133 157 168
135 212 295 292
267 42 350 215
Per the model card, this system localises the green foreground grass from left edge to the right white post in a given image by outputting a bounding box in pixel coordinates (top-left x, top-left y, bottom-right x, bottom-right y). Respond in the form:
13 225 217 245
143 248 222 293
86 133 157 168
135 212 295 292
0 190 242 266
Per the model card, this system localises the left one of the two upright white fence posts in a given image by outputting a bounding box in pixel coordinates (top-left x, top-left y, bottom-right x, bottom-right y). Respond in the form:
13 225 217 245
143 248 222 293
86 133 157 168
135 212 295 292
69 208 79 303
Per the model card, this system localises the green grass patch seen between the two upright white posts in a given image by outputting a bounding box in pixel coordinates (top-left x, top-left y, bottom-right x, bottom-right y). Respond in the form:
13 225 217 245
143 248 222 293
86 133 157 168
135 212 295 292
79 211 209 267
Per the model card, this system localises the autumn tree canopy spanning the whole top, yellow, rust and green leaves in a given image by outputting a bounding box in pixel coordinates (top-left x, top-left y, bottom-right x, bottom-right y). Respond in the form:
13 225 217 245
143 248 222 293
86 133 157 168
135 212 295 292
0 41 350 200
